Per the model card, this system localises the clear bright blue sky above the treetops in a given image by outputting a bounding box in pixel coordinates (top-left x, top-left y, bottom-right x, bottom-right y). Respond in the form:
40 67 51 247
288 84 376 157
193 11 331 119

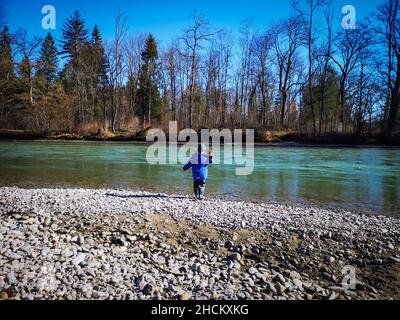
2 0 381 45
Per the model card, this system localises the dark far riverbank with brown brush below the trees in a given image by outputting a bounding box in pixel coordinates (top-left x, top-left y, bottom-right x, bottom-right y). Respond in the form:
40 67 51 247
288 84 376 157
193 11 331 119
0 130 400 147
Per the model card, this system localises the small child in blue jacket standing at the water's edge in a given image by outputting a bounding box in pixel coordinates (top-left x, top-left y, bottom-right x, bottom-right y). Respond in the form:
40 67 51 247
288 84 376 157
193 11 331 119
182 144 212 200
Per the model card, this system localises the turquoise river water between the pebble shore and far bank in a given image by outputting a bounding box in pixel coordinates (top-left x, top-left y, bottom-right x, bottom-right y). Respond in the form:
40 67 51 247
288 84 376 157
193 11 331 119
0 142 400 216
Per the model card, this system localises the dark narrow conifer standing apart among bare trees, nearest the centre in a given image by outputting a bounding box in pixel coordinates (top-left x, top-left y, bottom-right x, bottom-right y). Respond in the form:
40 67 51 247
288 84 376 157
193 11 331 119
138 34 162 125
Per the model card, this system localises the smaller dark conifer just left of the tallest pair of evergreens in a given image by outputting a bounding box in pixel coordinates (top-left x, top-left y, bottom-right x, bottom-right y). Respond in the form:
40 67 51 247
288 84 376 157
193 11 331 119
37 33 58 86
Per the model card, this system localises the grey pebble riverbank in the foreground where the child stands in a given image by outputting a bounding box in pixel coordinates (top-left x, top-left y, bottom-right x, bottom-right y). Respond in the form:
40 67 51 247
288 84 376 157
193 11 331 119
0 187 400 299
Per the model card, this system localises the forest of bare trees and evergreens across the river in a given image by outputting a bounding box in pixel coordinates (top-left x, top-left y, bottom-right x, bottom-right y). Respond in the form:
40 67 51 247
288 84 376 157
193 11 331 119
0 0 400 140
